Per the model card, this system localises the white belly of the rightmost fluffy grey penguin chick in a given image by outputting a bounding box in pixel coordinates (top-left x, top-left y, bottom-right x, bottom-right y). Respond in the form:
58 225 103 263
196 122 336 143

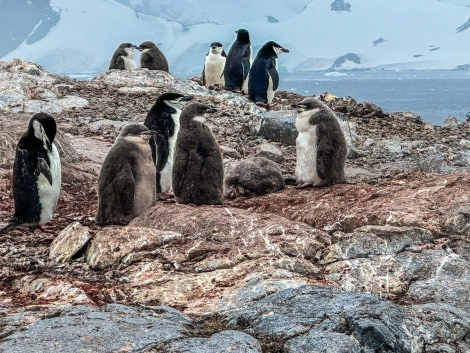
295 126 322 185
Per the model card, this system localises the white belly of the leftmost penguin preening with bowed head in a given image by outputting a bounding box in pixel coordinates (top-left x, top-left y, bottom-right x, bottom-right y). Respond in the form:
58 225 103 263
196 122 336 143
37 144 62 224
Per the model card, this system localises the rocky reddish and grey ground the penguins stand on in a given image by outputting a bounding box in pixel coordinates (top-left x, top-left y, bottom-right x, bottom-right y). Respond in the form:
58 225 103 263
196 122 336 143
0 61 470 353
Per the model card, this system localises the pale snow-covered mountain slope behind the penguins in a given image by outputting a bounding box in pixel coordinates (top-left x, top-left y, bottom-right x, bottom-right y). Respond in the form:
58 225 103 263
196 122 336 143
0 0 470 76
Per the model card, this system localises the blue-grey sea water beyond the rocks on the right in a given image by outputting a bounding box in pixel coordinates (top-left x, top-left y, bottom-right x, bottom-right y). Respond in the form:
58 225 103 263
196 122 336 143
278 70 470 125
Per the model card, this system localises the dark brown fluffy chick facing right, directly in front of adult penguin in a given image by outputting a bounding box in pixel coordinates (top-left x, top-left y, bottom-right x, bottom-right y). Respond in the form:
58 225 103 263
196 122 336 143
173 103 224 205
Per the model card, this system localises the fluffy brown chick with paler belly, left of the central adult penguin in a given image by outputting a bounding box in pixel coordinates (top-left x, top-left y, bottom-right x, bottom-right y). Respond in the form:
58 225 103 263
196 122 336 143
96 124 155 225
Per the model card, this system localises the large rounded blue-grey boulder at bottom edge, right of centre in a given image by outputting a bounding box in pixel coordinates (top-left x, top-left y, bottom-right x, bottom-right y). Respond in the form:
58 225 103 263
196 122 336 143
224 285 429 353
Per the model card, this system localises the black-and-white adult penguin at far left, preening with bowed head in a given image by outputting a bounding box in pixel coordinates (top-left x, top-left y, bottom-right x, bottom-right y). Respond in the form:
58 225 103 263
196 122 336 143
2 113 62 232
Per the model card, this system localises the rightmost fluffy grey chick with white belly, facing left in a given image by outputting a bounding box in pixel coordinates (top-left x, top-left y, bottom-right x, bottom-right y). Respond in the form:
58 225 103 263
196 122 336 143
292 97 347 187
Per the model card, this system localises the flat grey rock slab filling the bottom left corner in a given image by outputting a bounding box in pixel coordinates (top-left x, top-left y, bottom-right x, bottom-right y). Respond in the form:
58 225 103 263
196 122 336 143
0 304 191 353
